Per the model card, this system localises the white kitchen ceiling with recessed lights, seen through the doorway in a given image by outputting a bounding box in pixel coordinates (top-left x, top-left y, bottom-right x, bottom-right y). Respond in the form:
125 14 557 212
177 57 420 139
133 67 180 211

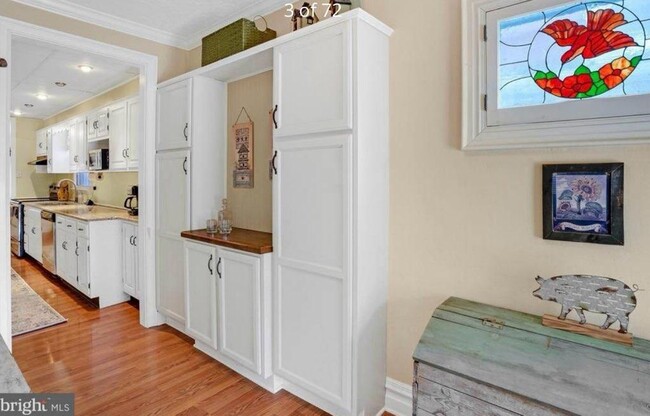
11 38 139 119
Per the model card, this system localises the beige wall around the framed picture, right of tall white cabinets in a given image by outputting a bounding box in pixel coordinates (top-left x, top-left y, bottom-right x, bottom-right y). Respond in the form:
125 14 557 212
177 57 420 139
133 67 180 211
191 0 650 383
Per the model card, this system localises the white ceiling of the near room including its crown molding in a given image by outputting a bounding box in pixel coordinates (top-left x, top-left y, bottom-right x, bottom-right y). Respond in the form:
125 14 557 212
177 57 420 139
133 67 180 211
14 0 288 49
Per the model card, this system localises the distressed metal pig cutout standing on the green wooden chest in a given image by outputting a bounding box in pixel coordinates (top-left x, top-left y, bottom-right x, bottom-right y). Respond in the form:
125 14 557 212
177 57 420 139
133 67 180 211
533 274 638 334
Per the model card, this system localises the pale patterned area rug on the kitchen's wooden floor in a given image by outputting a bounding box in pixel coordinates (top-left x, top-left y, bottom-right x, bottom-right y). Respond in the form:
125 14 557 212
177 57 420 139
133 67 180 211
11 270 67 336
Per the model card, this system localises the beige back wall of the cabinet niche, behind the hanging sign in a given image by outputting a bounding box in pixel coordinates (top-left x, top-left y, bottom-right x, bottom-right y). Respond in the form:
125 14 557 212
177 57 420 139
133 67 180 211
227 71 273 232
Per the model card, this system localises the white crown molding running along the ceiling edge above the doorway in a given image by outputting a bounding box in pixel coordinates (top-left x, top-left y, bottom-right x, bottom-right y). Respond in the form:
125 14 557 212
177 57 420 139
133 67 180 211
12 0 288 50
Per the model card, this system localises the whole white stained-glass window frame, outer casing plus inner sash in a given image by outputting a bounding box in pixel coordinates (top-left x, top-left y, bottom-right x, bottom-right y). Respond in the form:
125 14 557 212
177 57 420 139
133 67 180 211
462 0 650 150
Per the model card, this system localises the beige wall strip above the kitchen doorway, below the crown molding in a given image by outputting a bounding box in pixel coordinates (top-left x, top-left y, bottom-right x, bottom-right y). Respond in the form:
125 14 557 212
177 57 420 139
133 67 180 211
0 0 189 81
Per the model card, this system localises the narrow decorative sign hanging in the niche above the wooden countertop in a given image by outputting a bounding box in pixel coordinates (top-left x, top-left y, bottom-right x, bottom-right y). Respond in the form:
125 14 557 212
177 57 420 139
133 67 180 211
232 107 254 188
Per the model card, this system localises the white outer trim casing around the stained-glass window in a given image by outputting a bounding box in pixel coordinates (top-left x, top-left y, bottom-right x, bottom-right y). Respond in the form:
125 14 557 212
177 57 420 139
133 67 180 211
462 0 650 150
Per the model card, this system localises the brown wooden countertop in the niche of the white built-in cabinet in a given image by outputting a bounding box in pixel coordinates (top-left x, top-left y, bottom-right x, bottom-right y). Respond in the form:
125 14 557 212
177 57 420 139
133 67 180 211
181 228 273 254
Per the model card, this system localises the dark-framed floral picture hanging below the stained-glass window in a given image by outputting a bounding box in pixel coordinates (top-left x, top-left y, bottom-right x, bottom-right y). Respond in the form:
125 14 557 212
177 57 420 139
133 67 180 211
543 163 625 245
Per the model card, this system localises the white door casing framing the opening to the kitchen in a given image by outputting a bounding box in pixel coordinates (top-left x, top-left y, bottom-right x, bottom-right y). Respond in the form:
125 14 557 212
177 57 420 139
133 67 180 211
0 17 164 350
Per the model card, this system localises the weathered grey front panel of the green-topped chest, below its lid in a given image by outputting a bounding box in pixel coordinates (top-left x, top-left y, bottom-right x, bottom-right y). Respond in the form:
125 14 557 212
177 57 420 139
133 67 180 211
417 377 517 416
